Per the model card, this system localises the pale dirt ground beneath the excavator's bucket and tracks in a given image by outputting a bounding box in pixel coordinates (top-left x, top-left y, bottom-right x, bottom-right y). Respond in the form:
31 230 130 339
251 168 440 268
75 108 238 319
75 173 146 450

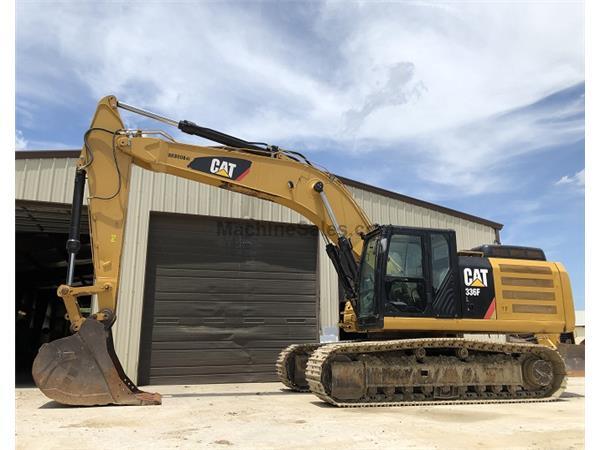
16 378 585 449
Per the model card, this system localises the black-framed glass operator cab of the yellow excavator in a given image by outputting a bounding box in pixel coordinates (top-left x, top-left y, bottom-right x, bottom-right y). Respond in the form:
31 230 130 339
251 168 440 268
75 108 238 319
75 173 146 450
357 225 461 328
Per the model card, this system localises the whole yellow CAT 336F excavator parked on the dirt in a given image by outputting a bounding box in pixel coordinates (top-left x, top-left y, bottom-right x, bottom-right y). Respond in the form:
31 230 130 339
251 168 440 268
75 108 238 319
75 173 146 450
32 96 574 406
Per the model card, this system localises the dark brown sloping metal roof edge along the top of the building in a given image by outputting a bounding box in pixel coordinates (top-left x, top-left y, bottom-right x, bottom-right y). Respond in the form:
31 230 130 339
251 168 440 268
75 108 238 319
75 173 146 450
15 150 504 231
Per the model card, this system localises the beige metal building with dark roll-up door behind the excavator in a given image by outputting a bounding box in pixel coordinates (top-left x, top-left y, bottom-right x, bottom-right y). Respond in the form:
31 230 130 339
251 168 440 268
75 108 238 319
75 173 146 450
16 150 502 384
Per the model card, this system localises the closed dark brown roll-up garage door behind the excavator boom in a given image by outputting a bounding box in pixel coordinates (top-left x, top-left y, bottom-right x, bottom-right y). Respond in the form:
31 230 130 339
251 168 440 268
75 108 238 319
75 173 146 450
138 213 318 384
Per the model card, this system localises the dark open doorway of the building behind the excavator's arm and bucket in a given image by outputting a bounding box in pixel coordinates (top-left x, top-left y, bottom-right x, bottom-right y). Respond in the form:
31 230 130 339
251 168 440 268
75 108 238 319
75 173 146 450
15 201 93 386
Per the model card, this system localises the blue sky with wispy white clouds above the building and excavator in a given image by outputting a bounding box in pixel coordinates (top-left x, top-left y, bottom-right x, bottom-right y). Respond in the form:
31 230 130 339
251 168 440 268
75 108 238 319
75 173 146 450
16 1 585 309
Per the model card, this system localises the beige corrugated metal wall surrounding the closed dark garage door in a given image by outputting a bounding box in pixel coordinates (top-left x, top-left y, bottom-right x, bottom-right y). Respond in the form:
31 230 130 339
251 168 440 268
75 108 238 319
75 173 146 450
15 158 495 382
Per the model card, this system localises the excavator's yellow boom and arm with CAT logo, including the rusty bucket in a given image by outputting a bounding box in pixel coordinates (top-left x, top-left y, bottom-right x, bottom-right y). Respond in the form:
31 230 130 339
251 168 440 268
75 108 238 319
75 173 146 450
32 96 372 405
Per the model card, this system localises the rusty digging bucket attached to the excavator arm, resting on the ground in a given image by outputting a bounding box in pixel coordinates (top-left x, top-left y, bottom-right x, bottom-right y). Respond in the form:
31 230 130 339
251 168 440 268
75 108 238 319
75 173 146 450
32 318 161 406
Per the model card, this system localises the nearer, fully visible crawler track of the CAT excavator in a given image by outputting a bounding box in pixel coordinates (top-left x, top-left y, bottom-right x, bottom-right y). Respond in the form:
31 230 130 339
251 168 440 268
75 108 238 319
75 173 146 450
306 338 567 407
